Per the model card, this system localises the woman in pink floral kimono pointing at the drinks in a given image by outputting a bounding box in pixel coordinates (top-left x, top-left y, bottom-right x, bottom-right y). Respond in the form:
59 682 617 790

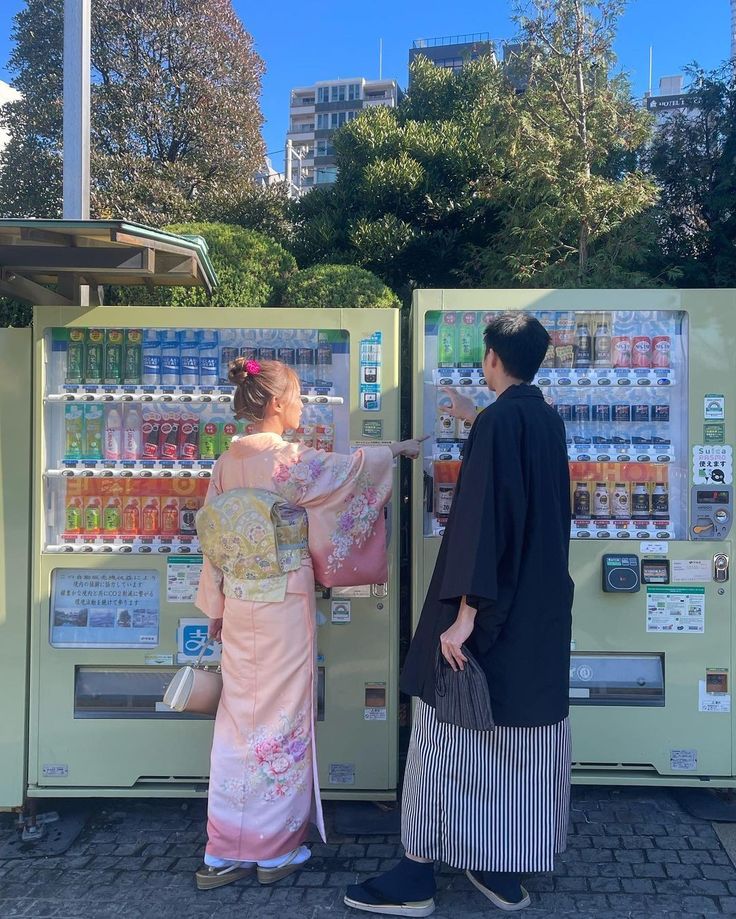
196 358 420 889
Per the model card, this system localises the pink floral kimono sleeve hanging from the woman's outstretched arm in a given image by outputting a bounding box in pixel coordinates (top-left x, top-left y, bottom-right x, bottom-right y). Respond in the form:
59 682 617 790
274 446 394 586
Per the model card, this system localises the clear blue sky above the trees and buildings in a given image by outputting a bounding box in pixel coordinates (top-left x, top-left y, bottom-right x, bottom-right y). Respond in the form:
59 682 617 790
0 0 730 168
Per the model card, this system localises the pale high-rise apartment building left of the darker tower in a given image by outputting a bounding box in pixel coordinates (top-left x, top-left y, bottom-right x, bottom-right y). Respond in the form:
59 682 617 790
286 77 401 195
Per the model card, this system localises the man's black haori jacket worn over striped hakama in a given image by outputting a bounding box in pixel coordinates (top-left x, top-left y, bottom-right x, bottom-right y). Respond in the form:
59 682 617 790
401 384 574 727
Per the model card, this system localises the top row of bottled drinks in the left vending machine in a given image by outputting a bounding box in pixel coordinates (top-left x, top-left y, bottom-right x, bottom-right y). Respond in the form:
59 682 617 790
65 329 333 387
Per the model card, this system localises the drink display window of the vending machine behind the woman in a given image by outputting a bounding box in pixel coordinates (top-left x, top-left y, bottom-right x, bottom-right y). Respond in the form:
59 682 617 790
43 328 352 554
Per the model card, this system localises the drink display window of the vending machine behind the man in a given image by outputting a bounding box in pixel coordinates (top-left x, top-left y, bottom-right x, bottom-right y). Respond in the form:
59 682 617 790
423 310 688 540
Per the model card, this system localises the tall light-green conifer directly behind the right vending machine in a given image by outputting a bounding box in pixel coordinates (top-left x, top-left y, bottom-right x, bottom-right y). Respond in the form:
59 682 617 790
474 0 657 286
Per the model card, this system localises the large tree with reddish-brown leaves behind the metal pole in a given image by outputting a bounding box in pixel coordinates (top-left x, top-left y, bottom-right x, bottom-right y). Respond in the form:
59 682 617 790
0 0 263 225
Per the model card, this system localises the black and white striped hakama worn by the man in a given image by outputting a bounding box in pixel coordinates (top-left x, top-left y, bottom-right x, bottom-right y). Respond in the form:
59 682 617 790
401 700 570 872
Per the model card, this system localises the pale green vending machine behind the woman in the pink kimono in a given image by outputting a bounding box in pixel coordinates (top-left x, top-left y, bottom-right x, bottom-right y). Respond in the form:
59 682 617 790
28 307 399 798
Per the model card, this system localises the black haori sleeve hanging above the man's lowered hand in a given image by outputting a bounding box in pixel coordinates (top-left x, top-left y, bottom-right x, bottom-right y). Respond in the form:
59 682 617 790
439 410 526 609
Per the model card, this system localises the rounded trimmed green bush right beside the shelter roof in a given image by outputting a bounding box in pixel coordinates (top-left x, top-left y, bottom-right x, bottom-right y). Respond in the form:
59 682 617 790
106 223 296 307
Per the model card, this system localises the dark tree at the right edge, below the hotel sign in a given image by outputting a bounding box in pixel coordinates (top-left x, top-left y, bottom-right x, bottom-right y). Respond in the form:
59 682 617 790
648 65 736 287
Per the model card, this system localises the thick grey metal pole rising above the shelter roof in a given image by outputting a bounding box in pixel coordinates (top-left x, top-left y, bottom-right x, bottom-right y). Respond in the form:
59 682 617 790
63 0 92 220
